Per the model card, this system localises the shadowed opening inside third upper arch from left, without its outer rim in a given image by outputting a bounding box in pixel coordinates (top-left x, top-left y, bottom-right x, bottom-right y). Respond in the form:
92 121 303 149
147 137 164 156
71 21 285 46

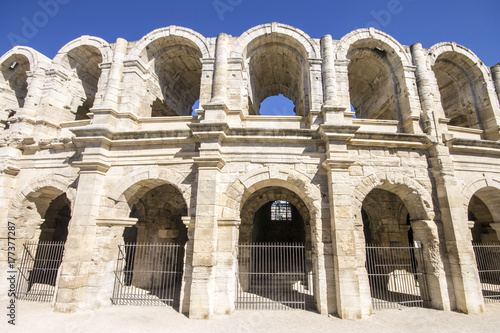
142 36 202 117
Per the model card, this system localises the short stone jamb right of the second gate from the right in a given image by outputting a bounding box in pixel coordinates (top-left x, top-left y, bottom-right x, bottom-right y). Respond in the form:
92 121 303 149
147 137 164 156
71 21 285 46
411 220 451 311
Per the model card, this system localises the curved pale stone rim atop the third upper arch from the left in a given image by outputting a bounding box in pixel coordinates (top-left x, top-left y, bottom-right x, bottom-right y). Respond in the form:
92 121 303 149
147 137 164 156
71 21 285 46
128 25 213 60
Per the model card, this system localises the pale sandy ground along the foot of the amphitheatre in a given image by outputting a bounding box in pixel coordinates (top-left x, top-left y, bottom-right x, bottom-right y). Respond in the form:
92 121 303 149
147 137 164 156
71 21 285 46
0 301 500 333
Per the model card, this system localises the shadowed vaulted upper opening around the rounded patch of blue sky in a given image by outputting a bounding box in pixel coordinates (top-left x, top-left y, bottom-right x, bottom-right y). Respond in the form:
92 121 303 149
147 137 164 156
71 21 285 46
244 33 309 115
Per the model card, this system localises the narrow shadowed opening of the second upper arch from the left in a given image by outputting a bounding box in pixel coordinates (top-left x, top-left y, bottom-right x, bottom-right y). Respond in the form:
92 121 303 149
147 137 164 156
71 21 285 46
62 45 103 120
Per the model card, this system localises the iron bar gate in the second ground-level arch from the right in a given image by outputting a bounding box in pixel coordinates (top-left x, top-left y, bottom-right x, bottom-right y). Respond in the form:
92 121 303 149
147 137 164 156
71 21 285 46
366 245 430 309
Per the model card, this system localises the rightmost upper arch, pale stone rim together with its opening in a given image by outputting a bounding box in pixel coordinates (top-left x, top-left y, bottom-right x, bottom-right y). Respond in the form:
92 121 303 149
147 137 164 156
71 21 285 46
427 42 498 130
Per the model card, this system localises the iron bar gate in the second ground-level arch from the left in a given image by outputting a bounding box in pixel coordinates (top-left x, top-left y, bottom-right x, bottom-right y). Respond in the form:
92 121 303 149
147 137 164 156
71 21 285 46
111 244 184 307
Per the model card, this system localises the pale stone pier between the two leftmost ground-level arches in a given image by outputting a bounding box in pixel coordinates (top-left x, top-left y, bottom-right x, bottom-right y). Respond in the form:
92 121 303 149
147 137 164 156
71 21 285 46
55 157 109 312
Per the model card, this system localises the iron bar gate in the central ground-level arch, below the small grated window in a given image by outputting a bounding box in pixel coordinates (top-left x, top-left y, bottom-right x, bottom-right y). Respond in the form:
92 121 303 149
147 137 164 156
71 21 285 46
235 243 313 310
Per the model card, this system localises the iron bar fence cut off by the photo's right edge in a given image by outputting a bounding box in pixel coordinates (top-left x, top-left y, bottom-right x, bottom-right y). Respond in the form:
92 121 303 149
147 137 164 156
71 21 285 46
473 244 500 302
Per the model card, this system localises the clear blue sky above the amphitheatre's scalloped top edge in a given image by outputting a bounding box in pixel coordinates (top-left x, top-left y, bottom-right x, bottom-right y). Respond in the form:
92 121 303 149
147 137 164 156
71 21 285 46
0 0 500 114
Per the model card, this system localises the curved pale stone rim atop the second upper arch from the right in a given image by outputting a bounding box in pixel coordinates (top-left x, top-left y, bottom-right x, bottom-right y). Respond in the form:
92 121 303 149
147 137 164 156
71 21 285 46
335 28 412 66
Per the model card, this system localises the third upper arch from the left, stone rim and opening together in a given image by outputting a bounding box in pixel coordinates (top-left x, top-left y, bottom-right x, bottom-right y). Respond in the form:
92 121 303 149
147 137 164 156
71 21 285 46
128 26 211 117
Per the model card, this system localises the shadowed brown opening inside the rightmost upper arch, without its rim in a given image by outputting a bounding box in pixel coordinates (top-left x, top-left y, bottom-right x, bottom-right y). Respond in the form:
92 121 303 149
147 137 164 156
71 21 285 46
432 51 494 129
